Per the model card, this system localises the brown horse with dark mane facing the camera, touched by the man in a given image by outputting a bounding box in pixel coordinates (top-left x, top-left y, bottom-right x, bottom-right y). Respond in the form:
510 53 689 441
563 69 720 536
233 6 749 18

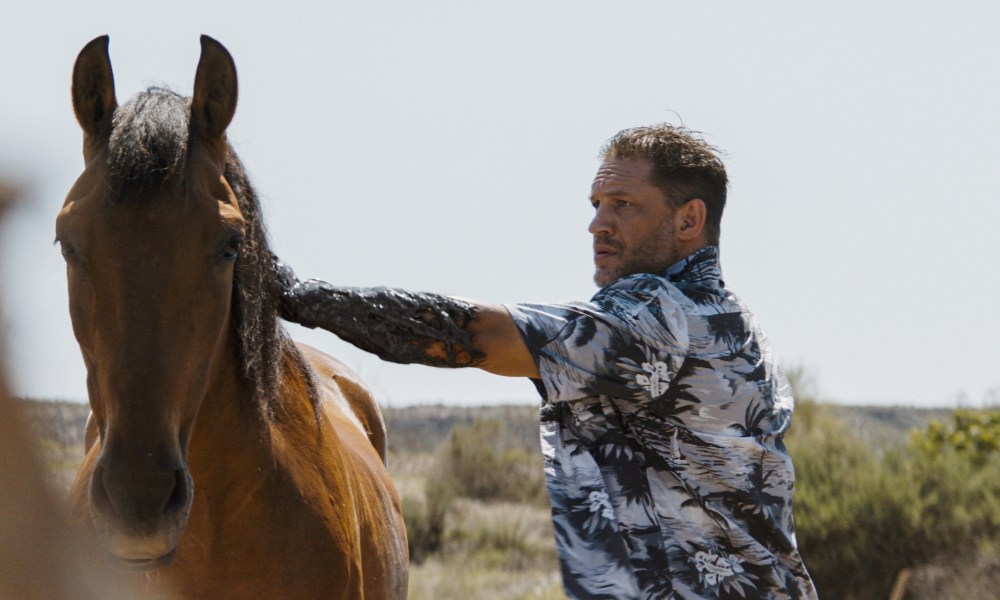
56 36 408 599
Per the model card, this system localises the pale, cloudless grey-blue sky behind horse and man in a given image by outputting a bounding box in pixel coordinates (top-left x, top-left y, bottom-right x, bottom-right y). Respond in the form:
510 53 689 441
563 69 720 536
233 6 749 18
0 0 1000 406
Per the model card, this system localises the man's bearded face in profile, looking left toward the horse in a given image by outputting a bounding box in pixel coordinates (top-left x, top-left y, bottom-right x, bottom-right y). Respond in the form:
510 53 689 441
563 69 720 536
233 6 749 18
589 158 680 287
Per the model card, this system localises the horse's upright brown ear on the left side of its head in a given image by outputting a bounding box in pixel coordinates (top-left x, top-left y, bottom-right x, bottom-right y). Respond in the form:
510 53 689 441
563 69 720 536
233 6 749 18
73 35 118 140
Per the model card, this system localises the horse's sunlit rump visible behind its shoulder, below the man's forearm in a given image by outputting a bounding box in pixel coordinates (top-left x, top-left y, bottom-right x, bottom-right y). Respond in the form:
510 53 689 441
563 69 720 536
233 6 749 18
296 342 386 463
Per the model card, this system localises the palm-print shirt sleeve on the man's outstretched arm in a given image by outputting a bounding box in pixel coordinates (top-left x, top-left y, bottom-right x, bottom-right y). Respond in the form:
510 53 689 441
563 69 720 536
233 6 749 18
505 275 688 403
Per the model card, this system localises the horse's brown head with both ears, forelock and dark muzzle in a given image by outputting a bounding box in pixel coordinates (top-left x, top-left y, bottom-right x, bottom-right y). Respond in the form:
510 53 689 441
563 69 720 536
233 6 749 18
56 36 247 568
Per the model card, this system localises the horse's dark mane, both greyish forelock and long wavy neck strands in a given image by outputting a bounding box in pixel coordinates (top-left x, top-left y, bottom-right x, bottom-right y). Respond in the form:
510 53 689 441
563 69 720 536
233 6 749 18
107 87 319 417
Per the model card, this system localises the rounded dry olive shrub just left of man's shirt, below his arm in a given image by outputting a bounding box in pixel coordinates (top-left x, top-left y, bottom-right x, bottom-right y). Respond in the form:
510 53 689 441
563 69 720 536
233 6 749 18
443 419 547 503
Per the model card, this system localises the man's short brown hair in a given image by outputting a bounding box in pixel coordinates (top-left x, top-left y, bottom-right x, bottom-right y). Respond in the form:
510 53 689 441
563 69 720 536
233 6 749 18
600 123 729 245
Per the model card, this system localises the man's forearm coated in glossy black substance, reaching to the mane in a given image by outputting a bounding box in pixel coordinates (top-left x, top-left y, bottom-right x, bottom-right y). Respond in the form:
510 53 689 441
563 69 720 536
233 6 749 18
281 280 484 367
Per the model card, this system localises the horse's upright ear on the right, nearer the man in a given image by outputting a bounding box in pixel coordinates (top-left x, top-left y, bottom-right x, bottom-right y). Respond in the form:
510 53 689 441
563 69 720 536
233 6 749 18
191 35 236 139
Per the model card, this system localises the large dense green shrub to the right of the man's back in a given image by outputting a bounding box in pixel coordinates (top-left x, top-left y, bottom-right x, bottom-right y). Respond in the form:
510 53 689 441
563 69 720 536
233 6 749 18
787 395 1000 600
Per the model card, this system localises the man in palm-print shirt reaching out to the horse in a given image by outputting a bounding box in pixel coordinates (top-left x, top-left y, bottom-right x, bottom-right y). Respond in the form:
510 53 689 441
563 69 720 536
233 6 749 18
274 125 816 599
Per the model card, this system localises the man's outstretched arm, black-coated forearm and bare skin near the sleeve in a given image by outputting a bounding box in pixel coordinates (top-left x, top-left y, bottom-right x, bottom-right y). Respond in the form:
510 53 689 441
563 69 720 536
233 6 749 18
278 263 538 377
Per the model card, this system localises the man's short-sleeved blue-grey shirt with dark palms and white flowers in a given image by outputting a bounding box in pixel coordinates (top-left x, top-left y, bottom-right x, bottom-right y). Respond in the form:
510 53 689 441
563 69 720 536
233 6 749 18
507 246 816 599
